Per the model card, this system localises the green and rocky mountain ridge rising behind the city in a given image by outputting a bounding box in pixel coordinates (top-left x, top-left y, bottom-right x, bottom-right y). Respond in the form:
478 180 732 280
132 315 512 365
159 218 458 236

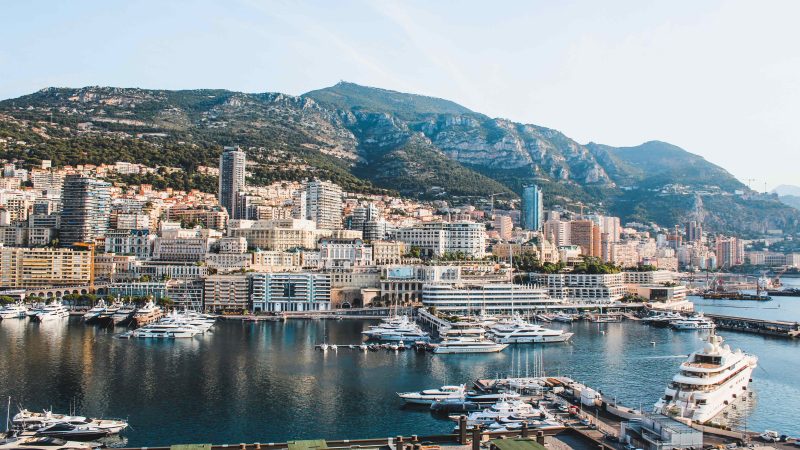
0 82 800 233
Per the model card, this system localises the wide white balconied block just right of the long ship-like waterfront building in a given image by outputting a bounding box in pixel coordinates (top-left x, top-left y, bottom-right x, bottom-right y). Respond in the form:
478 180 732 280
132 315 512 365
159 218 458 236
535 273 625 304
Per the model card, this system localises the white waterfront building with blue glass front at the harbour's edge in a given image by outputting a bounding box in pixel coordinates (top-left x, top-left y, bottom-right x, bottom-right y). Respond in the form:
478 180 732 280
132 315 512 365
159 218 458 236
250 273 331 312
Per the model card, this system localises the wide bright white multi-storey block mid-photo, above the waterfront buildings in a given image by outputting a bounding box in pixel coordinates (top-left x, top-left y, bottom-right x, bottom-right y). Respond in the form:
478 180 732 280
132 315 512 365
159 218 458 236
394 222 486 258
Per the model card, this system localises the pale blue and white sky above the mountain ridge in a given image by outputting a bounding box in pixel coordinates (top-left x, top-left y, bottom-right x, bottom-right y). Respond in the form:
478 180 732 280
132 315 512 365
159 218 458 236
0 0 800 190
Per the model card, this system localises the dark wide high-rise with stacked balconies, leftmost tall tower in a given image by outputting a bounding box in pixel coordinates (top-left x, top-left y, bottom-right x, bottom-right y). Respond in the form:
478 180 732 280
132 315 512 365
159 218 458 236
60 175 111 247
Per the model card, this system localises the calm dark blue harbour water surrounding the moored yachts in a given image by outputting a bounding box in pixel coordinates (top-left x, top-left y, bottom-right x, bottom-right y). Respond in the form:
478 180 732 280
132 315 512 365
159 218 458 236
0 308 800 446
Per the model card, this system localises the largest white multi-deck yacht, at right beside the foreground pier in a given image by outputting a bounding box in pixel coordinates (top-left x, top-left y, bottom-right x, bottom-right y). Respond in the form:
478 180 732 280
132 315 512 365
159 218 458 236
654 333 758 423
